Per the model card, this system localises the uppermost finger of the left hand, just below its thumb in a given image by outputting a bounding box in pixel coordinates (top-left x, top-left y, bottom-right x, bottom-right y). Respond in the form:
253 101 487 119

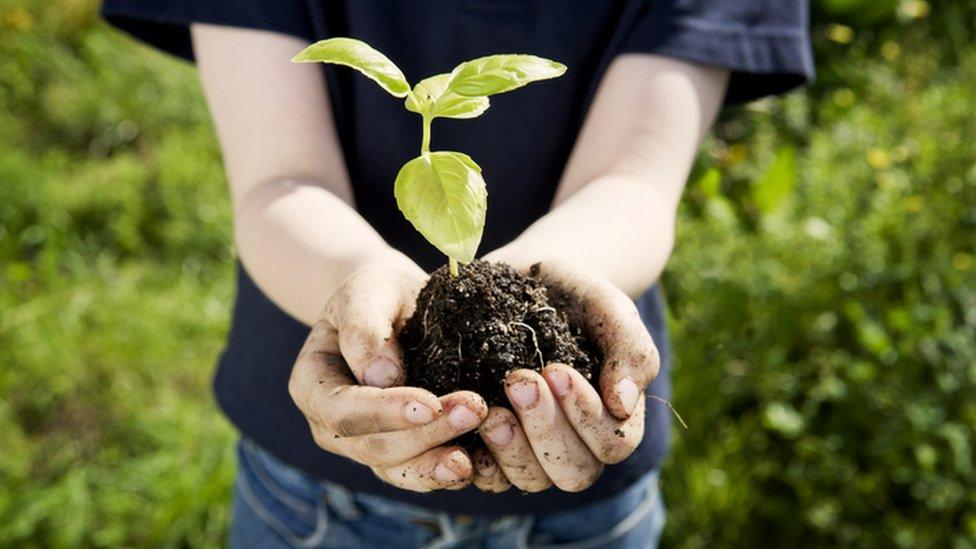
289 323 442 436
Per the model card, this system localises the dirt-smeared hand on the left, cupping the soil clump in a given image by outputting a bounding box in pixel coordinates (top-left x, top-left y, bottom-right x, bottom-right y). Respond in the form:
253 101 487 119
288 265 488 492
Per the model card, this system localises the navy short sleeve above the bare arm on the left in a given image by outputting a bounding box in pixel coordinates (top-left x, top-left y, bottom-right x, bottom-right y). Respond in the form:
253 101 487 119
101 0 314 61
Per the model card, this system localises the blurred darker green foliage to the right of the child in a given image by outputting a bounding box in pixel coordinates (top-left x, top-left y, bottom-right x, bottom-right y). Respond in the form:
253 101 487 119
663 0 976 548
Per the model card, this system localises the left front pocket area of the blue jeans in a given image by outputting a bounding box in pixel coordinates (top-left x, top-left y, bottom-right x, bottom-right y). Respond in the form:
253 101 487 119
235 440 330 547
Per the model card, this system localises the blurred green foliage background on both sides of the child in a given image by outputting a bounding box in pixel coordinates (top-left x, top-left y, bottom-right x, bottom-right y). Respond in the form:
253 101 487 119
0 0 976 548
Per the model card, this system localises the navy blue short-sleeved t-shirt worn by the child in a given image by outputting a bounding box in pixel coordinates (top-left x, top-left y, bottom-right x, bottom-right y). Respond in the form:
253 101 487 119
103 0 813 516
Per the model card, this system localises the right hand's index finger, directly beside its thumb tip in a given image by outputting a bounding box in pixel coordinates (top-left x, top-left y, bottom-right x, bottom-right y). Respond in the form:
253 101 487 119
542 364 644 464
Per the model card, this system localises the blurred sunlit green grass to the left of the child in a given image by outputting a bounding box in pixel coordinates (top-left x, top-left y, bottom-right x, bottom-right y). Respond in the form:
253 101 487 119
0 0 234 547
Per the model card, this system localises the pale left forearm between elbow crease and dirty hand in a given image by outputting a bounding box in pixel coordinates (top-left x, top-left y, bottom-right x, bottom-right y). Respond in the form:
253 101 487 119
234 179 423 324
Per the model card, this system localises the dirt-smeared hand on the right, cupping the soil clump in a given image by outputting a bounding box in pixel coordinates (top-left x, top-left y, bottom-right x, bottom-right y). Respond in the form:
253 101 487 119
473 262 660 492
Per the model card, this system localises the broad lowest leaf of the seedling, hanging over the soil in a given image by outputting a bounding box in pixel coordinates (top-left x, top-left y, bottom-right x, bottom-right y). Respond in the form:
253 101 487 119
393 151 488 263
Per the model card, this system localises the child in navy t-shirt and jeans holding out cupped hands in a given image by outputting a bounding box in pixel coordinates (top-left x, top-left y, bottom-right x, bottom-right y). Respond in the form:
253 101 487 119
103 0 812 548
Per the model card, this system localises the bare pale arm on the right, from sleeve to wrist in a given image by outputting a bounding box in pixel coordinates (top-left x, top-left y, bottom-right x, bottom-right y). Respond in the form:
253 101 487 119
490 55 728 297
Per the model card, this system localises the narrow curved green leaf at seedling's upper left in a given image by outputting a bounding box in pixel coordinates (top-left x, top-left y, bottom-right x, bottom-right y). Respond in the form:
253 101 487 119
291 38 410 97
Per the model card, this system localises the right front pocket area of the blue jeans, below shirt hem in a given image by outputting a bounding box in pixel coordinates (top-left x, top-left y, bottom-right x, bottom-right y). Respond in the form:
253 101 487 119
529 473 665 549
